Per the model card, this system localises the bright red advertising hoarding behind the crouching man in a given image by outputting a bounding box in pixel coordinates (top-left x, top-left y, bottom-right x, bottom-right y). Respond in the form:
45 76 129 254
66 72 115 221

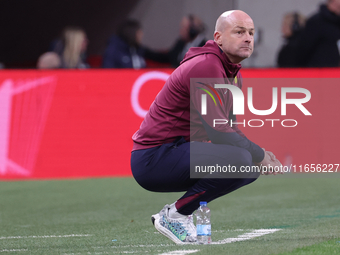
0 69 340 180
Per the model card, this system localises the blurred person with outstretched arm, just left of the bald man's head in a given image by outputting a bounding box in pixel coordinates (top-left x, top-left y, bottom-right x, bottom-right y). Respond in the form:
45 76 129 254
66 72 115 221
145 14 207 67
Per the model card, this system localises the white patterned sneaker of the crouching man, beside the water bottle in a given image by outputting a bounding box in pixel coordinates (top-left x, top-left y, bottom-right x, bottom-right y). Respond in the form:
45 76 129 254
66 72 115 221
151 205 197 244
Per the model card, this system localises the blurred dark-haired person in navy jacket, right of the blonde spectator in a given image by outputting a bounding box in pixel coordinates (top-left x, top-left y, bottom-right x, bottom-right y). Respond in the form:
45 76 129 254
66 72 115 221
103 20 146 69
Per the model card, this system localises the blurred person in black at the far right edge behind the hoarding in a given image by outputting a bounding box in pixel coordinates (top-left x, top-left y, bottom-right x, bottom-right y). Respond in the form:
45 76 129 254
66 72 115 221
298 0 340 67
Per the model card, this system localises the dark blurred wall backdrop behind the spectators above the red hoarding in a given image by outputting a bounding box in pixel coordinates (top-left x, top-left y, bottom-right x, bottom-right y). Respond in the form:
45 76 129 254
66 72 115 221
0 0 324 68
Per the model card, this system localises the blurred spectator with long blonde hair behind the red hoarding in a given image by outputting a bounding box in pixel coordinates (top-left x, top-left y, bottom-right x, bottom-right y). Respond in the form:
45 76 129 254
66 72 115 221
61 27 89 68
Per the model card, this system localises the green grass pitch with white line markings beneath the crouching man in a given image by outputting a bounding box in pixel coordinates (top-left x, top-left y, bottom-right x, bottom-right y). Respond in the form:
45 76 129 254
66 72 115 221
0 176 340 255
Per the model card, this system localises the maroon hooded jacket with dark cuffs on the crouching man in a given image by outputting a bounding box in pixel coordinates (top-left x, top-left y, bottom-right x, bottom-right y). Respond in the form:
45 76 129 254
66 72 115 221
132 40 264 162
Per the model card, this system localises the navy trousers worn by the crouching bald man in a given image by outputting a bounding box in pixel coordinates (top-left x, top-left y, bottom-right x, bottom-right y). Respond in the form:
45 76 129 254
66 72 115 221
131 137 259 215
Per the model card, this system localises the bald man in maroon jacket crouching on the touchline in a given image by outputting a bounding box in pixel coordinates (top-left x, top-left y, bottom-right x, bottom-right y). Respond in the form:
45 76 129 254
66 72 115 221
131 10 281 244
